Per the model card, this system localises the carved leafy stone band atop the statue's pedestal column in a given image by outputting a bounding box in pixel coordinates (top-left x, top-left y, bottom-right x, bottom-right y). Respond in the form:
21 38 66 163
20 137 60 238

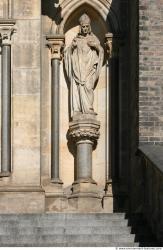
68 121 100 143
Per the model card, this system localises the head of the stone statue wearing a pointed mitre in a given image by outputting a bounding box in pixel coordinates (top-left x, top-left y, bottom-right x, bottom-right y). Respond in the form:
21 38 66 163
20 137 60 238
79 14 91 36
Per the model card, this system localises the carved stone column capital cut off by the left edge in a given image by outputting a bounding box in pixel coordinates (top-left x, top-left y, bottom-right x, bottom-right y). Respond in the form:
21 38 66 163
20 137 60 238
0 19 16 46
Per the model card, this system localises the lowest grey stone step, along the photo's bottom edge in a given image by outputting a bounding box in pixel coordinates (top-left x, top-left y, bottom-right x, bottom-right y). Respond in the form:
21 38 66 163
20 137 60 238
0 234 135 246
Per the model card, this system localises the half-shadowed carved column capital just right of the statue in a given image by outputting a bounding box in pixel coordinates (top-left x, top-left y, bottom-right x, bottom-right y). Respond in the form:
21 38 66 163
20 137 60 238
105 33 120 58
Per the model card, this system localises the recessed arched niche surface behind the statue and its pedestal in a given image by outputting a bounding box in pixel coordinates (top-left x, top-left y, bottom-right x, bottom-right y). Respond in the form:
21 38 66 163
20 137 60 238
60 1 112 188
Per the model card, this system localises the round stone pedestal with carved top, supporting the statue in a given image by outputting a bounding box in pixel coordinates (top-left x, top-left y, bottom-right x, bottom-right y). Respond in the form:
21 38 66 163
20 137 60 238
68 114 101 212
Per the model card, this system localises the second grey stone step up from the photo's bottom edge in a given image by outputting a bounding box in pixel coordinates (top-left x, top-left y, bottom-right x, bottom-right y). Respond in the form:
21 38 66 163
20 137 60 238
0 225 131 236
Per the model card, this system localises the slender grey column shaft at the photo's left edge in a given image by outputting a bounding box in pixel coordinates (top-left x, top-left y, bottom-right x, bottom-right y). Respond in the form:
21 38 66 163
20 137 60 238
1 44 11 175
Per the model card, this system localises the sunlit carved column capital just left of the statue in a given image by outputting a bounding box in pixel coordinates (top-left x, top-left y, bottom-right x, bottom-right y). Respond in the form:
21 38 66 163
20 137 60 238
46 35 65 60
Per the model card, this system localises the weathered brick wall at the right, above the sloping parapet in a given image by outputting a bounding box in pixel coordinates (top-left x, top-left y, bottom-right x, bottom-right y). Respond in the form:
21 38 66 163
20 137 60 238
139 0 163 144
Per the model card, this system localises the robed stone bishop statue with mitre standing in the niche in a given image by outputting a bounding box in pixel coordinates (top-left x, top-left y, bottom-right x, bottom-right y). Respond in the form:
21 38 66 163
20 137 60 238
64 14 104 117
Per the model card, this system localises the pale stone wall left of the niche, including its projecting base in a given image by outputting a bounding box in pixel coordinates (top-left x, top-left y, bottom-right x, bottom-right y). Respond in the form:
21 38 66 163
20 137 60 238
0 0 45 213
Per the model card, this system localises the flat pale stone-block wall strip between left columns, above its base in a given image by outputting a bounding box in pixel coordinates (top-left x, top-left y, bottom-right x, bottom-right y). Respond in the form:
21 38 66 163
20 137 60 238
12 0 41 185
